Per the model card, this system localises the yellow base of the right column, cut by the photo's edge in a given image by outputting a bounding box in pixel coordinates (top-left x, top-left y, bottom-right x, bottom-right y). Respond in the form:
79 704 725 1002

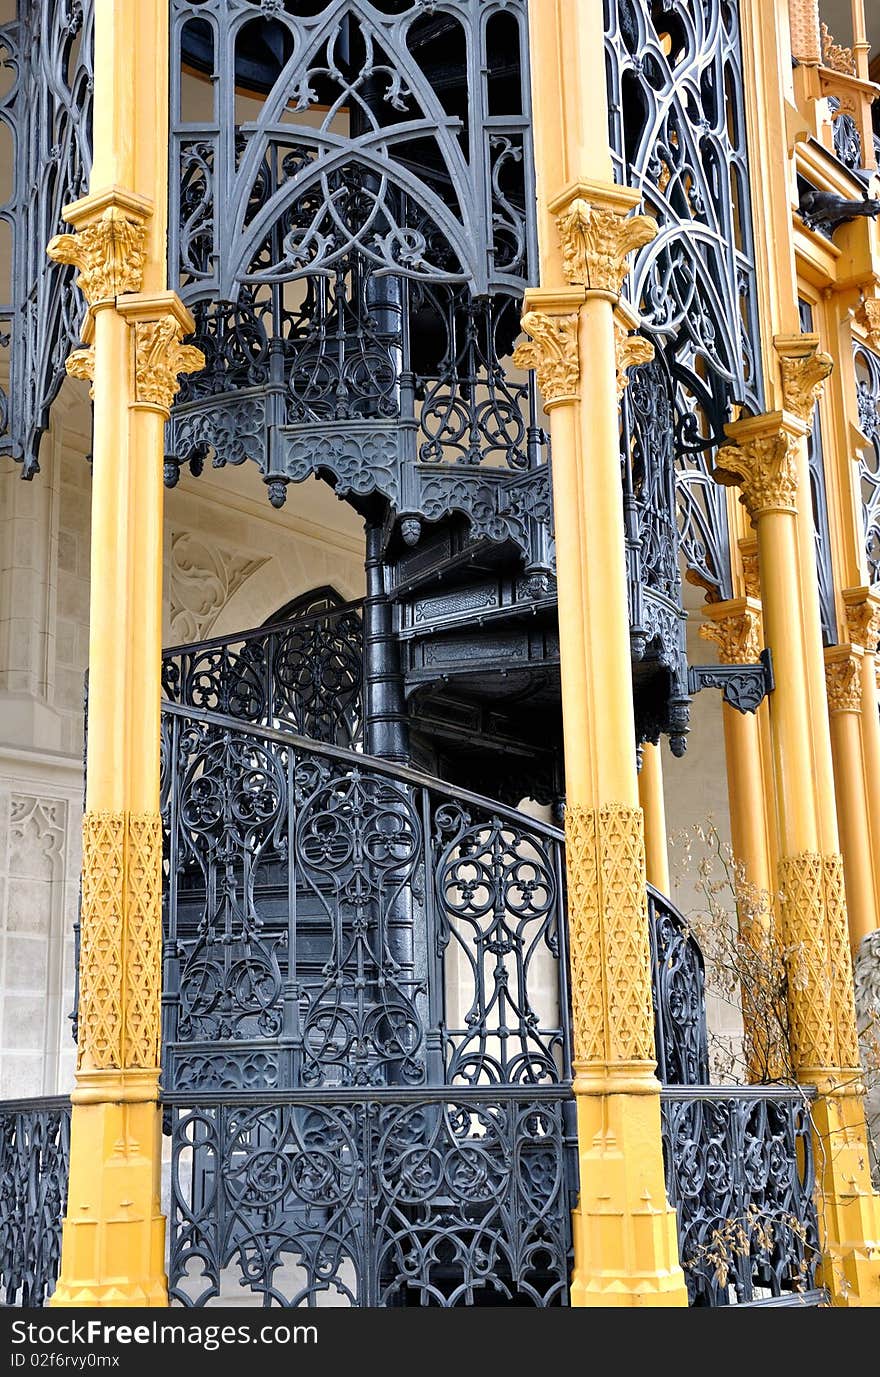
813 1093 880 1307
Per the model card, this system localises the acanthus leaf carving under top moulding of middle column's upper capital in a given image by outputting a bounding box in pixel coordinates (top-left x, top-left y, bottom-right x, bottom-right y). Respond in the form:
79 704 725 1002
556 196 658 297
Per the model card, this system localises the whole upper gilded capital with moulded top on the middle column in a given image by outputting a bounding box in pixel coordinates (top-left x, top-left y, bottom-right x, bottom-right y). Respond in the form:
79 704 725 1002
549 182 658 300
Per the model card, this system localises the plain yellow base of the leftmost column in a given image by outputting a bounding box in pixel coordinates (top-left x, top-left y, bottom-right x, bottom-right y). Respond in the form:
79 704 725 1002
48 1099 168 1308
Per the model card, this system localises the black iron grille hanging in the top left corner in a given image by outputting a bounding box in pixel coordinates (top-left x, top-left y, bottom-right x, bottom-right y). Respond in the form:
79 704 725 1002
0 0 94 478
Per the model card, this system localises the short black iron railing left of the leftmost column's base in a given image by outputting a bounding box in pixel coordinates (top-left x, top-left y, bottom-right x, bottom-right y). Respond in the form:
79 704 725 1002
0 1096 70 1307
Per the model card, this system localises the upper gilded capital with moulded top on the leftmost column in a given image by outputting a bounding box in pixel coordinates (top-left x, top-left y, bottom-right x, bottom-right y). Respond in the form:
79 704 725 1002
45 187 151 307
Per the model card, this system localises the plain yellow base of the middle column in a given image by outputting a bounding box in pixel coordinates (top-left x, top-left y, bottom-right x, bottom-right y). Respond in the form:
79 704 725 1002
572 1089 687 1308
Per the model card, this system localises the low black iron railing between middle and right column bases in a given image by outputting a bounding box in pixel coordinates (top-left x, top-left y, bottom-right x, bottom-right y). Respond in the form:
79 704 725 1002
661 1085 824 1307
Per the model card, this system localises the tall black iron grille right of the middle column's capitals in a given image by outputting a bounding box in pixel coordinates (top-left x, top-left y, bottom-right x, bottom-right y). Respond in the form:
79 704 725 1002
606 0 763 753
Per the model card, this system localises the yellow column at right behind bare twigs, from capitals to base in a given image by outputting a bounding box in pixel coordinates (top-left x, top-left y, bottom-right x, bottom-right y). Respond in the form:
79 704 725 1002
716 349 880 1305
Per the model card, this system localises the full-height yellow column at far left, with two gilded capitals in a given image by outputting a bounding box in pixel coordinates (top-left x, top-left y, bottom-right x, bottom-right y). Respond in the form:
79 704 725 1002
48 0 204 1307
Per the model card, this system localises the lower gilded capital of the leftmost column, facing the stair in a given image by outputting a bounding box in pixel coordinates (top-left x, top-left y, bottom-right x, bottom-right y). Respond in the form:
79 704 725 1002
117 292 205 412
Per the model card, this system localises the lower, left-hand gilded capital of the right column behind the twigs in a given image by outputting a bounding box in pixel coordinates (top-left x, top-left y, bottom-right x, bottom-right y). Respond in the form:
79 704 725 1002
712 412 807 521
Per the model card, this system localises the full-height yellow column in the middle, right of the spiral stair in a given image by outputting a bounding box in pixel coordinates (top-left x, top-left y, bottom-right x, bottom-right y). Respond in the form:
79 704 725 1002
516 0 687 1307
